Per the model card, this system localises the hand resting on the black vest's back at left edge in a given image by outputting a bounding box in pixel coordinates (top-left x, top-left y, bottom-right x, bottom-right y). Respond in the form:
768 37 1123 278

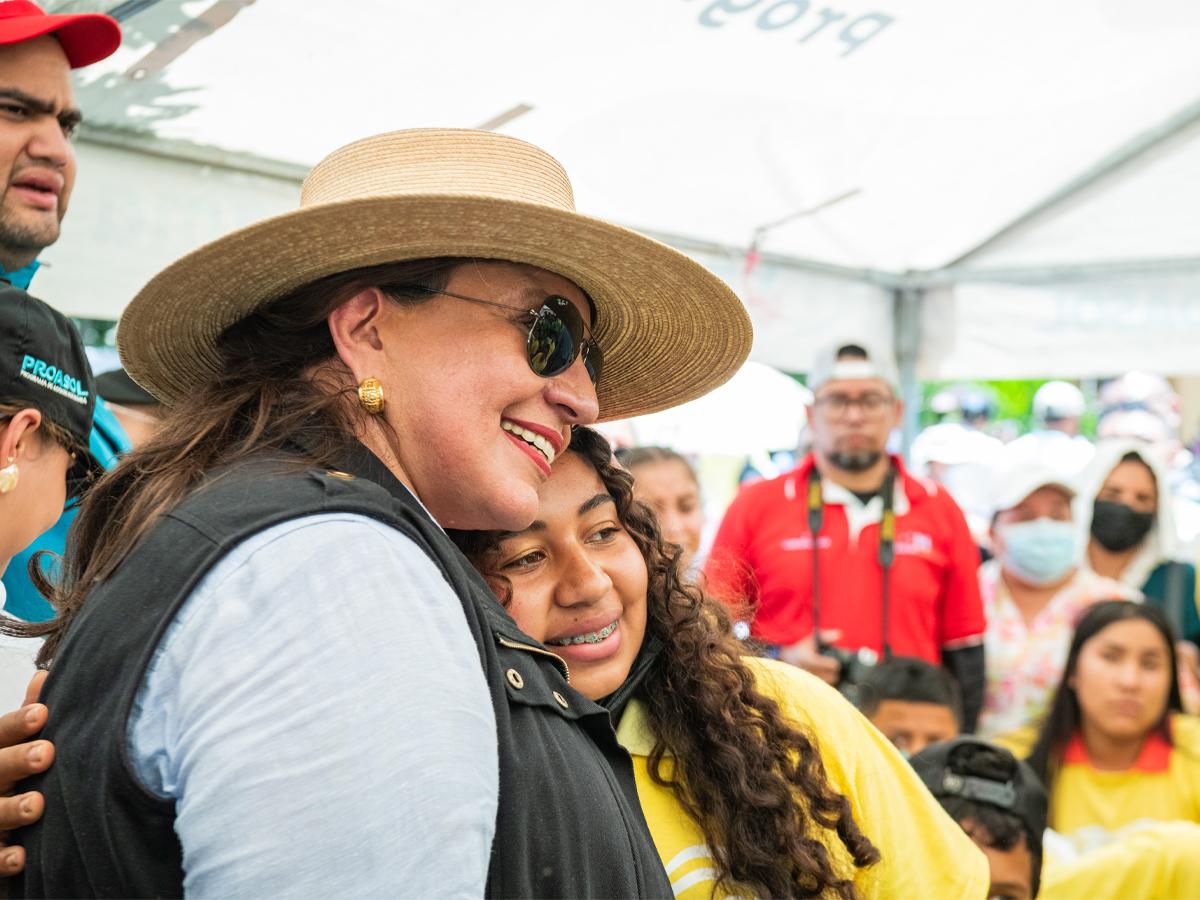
0 672 54 875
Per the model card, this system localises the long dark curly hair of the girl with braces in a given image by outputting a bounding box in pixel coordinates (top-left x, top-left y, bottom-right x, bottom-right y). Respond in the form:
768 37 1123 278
451 428 880 898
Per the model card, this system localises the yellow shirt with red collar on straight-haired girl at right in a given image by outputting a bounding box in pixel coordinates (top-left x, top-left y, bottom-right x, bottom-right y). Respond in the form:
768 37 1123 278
1050 715 1200 844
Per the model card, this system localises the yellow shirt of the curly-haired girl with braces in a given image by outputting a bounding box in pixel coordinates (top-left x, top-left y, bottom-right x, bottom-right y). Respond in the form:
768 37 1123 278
617 658 989 900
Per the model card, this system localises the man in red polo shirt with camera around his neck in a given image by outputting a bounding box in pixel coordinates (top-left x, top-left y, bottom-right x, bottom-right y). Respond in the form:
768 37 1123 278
704 341 984 731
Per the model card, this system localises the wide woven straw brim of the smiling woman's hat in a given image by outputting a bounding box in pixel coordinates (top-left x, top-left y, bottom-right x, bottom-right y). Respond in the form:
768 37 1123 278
118 194 752 421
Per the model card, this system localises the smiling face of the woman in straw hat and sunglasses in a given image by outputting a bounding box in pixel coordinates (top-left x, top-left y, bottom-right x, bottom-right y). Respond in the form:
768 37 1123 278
360 262 599 529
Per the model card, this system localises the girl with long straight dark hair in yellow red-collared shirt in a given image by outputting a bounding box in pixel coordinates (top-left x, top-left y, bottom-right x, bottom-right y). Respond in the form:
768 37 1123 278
1014 600 1200 850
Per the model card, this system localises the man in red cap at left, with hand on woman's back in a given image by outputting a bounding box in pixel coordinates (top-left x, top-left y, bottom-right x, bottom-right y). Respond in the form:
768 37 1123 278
0 0 121 875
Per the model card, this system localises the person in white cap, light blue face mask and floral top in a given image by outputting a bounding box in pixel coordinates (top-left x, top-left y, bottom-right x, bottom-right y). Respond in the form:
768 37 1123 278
977 457 1141 738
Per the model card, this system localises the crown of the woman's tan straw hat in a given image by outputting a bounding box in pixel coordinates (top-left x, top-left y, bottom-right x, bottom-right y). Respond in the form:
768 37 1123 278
300 130 575 211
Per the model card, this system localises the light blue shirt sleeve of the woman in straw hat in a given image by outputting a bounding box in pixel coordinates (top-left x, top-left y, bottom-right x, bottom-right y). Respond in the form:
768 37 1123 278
128 514 498 898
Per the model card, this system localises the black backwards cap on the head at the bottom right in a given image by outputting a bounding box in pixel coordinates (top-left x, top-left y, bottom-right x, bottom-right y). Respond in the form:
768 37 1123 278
908 737 1046 836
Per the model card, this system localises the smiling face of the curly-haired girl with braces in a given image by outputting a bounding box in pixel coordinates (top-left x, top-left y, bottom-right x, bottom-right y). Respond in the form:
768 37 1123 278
492 452 647 700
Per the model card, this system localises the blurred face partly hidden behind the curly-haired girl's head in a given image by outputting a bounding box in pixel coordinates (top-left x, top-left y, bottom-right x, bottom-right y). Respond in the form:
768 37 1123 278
617 446 704 574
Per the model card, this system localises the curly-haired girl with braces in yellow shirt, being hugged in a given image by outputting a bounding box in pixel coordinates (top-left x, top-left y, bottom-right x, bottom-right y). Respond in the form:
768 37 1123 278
451 428 988 900
